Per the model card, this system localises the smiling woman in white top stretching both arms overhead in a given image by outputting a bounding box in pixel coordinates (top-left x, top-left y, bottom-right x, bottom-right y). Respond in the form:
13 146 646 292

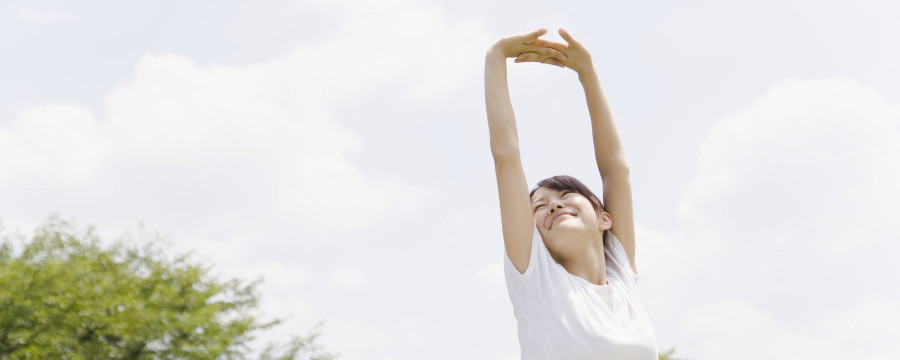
484 29 658 360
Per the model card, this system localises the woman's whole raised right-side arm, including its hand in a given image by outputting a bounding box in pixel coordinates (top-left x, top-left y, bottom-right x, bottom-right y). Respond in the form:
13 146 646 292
536 29 637 272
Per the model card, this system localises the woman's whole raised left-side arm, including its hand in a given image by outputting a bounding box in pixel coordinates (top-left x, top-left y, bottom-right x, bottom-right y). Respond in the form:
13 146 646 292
484 29 563 273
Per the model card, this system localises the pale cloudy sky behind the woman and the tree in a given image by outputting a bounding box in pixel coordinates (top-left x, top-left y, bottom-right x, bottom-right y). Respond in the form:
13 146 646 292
0 0 900 360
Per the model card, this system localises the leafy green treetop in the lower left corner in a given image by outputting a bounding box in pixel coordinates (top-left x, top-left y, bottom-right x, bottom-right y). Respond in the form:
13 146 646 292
0 216 334 360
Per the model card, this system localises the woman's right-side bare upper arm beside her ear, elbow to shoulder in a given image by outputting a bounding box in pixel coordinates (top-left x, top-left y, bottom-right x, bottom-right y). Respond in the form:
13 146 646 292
602 166 637 273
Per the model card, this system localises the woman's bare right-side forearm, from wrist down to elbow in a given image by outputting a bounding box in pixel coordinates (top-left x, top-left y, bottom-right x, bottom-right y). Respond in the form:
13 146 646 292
578 67 628 176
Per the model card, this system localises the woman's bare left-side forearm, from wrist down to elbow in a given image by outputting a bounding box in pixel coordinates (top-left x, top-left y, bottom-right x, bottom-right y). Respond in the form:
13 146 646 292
484 47 519 158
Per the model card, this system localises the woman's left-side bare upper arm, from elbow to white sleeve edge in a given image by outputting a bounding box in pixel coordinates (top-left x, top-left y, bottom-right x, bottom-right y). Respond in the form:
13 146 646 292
494 154 534 273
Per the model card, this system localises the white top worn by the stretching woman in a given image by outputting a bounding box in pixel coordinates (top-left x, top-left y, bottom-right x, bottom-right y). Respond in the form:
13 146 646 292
503 227 659 360
